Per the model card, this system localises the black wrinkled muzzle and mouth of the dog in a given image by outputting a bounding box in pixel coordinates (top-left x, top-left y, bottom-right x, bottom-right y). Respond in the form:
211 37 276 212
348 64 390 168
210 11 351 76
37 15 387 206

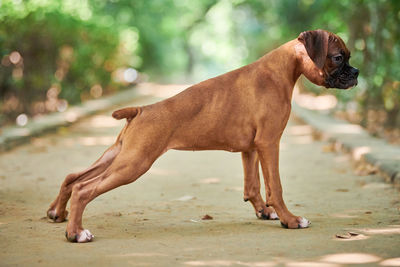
325 64 359 89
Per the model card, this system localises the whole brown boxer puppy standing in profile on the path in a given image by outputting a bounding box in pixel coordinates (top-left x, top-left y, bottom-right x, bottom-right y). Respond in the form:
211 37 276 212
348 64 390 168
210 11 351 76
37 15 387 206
47 30 359 243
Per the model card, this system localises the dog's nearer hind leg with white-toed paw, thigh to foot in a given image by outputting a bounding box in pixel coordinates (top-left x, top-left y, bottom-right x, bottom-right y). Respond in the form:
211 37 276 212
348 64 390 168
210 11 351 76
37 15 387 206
66 149 162 243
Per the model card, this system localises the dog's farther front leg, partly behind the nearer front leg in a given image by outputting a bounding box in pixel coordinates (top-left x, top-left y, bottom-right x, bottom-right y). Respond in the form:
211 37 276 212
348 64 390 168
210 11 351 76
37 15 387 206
242 151 278 220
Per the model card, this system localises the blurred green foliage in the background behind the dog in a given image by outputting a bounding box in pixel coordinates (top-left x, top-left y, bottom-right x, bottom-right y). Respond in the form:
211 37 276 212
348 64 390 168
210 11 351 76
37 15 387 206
0 0 400 130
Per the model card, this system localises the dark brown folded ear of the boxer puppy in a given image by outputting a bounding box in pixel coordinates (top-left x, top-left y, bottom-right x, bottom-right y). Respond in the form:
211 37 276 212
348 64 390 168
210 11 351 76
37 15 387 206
297 30 329 69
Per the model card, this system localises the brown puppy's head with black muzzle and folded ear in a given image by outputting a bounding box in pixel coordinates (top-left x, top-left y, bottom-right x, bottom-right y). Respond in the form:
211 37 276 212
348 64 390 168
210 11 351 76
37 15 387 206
297 30 359 89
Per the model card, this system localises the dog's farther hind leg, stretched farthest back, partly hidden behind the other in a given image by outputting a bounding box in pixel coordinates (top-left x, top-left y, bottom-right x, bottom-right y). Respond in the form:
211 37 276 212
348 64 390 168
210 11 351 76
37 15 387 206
47 143 121 222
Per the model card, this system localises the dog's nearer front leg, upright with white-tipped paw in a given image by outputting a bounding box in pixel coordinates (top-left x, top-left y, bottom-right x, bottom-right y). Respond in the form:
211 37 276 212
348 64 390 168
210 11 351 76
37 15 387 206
257 143 310 228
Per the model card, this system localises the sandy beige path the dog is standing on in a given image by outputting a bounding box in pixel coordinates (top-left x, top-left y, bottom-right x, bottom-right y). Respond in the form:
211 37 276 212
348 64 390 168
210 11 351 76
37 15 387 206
0 93 400 266
